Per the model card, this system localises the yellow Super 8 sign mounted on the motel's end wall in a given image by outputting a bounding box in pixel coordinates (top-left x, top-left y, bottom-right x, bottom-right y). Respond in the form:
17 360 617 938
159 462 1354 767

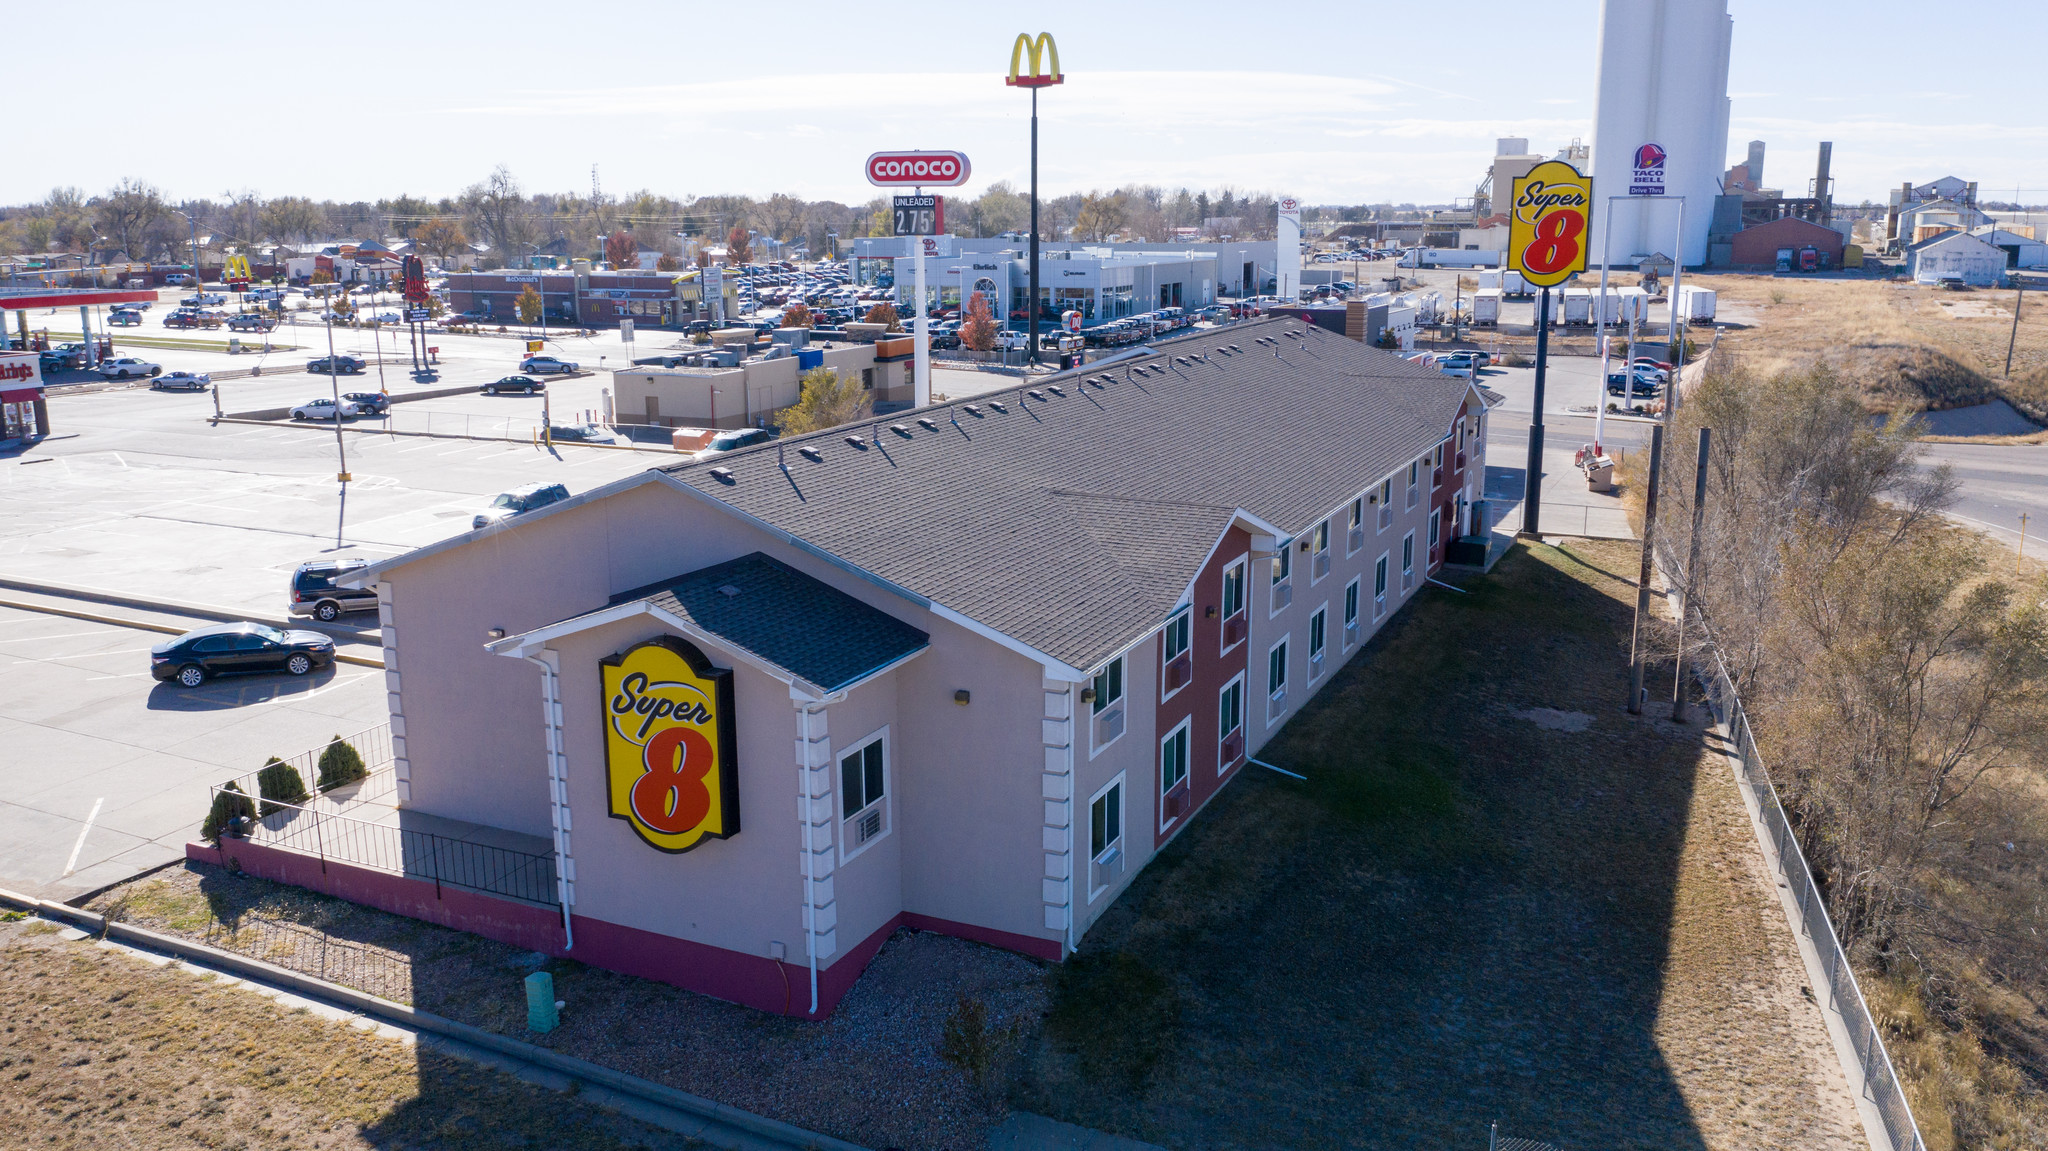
600 635 739 852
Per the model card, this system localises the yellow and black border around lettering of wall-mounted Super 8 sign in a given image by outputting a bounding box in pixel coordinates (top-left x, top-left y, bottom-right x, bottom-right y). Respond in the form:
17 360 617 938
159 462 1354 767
598 635 739 854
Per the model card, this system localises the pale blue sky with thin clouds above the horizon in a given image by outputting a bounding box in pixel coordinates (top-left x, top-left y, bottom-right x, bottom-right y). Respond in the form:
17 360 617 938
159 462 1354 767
19 0 2048 203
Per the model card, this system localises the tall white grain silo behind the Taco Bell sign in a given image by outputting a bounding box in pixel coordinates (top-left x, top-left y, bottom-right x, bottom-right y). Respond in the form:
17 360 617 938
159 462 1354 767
1589 0 1733 266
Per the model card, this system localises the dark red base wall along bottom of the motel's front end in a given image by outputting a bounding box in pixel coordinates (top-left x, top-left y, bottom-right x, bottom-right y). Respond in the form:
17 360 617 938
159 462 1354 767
184 840 1063 1018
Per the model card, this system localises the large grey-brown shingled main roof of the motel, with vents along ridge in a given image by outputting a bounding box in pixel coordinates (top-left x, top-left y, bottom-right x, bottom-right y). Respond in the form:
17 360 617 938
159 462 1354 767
662 319 1470 670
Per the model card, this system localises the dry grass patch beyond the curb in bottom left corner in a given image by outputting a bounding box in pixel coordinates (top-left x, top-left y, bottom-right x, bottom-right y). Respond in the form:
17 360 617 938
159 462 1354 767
0 920 702 1151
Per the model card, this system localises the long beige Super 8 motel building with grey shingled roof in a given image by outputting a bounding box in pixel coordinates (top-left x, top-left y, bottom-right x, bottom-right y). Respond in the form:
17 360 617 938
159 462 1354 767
303 319 1485 1016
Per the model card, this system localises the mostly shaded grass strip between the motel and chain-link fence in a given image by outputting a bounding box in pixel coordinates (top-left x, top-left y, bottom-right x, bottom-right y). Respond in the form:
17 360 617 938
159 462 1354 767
1016 543 1864 1151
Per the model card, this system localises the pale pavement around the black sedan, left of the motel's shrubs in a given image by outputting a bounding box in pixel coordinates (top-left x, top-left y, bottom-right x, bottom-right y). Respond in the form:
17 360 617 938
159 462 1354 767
0 608 387 899
